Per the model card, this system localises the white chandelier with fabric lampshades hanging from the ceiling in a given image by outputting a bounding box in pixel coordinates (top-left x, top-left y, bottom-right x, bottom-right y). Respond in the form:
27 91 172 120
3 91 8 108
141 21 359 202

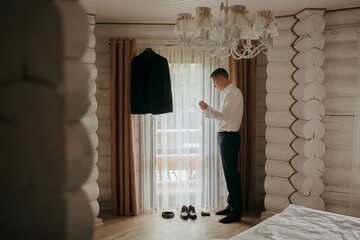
175 1 278 59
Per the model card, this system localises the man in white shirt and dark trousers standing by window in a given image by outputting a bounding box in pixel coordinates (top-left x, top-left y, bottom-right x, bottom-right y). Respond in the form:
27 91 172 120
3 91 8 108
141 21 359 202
199 68 244 223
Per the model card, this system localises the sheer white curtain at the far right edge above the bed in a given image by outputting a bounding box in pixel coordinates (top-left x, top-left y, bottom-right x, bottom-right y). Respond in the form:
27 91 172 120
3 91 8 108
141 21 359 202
349 30 360 214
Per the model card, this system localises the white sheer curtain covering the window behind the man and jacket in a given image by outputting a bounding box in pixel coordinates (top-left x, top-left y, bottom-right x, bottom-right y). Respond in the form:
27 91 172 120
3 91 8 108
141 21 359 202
134 46 228 211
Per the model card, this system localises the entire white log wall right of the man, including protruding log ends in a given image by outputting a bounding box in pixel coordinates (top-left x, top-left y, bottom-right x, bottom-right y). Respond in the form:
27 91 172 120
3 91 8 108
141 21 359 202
265 8 360 216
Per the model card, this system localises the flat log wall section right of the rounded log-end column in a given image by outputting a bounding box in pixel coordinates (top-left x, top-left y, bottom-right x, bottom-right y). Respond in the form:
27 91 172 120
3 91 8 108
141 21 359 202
322 9 360 217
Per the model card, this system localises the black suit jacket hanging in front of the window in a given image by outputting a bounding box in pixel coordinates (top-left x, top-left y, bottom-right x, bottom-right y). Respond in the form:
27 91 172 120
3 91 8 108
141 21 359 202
130 50 173 114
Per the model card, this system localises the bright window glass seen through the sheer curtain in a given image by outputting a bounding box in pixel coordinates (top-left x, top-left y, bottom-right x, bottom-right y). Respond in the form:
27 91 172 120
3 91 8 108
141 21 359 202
156 63 202 195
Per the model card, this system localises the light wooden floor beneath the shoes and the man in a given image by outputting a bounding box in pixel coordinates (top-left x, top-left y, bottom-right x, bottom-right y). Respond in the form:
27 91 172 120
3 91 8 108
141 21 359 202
93 211 261 240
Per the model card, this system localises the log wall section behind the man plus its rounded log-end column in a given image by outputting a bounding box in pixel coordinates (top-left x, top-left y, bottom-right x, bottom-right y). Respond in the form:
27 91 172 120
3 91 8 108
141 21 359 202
265 9 325 216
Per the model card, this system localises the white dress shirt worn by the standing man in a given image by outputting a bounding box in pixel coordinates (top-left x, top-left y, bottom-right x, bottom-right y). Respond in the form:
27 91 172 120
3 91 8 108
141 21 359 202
204 83 244 132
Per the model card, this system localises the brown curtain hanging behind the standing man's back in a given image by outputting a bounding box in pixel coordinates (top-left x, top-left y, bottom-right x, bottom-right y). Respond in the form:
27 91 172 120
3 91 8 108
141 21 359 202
229 46 256 210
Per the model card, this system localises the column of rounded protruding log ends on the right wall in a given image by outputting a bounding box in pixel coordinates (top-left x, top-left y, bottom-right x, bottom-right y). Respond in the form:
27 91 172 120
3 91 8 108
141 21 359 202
290 9 325 210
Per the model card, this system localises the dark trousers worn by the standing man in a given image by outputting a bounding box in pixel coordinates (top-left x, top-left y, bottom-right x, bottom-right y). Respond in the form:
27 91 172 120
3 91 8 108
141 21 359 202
217 132 242 214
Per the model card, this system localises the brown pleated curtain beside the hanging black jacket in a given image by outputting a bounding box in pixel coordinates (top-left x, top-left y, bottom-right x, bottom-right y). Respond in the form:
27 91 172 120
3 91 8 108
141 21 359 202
110 38 138 216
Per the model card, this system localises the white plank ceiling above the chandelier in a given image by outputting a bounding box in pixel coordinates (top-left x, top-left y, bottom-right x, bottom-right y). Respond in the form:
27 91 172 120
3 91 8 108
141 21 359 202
80 0 360 23
